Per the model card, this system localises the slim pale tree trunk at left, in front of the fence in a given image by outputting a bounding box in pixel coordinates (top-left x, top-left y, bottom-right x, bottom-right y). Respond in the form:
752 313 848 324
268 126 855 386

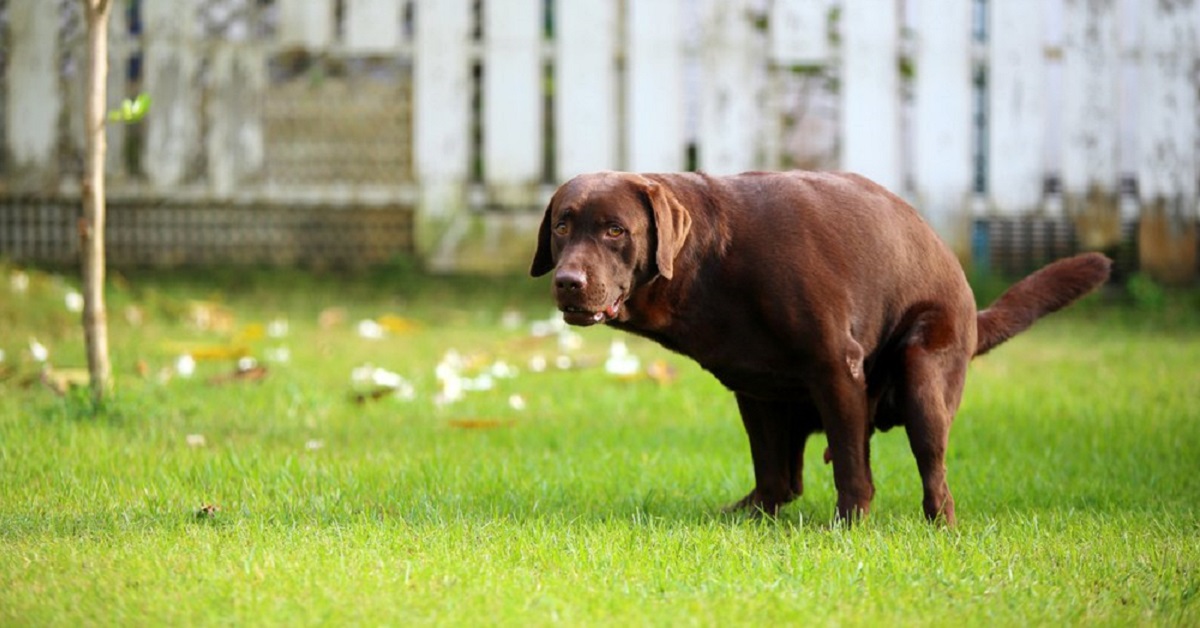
79 0 112 403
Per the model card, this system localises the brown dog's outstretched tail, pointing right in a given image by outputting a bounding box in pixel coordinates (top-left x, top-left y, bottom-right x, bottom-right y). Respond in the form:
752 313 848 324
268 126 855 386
974 253 1112 355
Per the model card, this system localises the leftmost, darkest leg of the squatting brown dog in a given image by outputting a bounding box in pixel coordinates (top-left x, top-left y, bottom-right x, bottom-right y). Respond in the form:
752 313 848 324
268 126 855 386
727 393 815 515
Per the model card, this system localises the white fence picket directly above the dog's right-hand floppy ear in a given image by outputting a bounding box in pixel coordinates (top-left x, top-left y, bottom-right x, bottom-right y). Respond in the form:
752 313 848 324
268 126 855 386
624 0 686 172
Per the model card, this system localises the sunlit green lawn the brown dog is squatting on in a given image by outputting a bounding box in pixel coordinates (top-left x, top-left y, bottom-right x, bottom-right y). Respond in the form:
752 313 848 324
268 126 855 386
0 265 1200 626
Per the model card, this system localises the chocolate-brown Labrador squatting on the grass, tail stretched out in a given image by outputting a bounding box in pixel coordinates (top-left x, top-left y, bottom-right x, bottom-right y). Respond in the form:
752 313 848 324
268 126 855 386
530 172 1110 525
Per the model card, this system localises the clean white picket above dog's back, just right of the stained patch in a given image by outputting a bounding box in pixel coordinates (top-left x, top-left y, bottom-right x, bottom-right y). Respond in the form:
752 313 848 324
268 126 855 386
841 0 904 193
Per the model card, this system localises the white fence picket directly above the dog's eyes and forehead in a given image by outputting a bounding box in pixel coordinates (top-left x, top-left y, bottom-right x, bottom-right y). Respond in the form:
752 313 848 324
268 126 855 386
554 0 618 180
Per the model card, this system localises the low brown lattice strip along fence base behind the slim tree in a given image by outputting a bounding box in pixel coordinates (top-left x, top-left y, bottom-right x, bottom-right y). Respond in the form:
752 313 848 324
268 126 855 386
0 198 414 268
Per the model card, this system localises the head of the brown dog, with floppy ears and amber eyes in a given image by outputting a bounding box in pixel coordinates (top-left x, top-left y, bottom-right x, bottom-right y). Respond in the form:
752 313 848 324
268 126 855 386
529 172 691 325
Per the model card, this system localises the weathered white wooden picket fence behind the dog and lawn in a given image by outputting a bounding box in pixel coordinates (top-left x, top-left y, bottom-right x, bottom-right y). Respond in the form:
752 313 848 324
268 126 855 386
2 0 1200 273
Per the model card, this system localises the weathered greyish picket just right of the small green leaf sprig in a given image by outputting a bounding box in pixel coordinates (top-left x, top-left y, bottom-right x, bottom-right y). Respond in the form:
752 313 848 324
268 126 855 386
142 0 200 187
